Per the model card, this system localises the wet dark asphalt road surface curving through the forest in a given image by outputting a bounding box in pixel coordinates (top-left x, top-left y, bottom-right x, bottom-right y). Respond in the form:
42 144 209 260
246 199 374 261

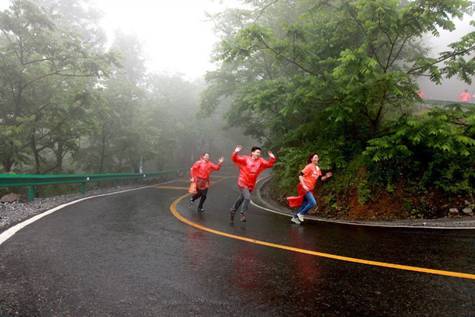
0 179 475 316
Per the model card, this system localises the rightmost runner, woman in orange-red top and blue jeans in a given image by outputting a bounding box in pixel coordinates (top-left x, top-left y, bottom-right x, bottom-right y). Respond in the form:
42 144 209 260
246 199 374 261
291 153 333 224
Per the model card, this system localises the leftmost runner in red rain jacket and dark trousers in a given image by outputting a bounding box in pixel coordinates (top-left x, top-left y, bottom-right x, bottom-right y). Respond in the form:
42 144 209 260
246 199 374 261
190 153 224 212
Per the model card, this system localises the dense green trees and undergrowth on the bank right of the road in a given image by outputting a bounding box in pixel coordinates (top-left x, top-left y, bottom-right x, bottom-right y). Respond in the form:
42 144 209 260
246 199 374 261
202 0 475 219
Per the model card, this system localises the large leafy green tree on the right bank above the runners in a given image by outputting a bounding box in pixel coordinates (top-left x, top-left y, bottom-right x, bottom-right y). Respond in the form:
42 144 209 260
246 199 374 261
202 0 475 215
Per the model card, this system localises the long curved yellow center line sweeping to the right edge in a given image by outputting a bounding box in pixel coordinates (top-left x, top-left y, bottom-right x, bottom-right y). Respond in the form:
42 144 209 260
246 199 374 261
170 194 475 280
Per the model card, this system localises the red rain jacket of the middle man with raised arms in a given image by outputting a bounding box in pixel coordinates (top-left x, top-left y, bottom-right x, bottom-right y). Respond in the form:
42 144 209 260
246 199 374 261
231 152 277 191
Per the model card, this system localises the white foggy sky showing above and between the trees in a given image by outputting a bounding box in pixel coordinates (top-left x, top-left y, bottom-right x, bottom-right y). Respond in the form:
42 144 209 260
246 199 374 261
0 0 475 94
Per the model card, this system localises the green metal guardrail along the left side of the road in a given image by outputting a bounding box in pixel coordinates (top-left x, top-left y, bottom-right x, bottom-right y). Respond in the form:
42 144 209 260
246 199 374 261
0 169 181 201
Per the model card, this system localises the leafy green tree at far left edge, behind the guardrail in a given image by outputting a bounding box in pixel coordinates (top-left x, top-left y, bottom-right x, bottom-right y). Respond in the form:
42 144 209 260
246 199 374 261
0 0 113 172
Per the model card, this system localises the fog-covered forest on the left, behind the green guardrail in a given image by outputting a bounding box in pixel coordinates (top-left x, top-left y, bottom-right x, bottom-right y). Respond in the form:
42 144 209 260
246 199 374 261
0 0 249 174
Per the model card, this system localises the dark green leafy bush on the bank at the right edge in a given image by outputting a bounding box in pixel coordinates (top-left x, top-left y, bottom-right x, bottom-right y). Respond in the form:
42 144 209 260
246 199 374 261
364 107 475 194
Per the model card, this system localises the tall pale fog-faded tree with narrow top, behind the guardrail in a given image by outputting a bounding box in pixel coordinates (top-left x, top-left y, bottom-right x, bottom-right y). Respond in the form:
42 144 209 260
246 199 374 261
80 32 159 172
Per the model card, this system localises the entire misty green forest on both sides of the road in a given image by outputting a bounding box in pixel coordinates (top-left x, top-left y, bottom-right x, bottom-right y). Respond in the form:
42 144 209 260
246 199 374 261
0 0 475 218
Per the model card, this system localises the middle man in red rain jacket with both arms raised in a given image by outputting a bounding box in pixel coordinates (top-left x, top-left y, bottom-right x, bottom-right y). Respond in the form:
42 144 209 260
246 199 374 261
231 145 277 222
